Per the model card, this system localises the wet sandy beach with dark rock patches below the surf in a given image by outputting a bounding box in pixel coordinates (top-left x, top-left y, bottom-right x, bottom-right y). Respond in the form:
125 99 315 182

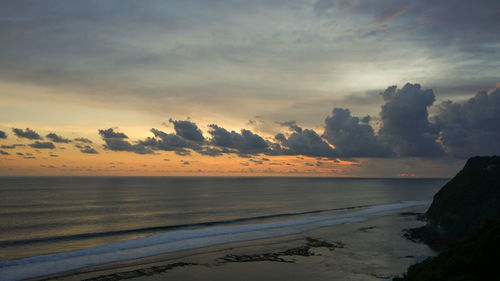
32 203 435 281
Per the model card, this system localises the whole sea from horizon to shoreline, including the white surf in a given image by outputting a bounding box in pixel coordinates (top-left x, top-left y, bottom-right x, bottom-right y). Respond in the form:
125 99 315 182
0 177 447 280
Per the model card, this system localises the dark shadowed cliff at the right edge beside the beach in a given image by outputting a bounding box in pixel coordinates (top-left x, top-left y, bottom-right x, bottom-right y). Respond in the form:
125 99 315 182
400 156 500 281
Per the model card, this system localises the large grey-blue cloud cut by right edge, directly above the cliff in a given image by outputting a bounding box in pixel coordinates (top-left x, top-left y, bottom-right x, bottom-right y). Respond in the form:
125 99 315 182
435 87 500 158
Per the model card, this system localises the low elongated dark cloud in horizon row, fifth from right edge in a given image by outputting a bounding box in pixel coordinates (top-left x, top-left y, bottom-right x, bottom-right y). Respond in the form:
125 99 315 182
208 124 269 155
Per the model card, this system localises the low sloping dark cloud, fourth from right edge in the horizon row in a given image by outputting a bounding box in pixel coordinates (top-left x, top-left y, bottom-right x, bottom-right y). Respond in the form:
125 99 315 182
273 121 338 157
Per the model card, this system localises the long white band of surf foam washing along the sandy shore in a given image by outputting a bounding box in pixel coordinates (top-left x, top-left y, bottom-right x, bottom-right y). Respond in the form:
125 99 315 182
0 201 431 281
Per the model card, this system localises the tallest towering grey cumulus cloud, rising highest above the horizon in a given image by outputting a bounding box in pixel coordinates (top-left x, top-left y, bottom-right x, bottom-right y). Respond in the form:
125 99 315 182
378 83 444 157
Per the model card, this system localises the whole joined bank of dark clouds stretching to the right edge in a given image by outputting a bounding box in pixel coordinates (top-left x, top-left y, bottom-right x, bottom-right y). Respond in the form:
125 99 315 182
94 83 500 158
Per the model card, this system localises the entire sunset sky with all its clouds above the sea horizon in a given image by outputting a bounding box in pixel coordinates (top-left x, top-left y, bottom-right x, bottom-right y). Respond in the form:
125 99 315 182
0 0 500 177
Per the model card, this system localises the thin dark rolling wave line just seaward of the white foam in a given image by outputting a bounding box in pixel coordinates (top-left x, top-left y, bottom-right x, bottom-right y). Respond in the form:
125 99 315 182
0 202 373 247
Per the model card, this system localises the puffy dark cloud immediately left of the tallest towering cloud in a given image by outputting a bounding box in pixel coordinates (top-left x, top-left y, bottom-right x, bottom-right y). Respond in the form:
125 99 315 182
323 108 390 157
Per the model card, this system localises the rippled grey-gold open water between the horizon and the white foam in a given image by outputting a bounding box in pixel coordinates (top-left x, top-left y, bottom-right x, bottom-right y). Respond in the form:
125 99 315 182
0 177 447 261
